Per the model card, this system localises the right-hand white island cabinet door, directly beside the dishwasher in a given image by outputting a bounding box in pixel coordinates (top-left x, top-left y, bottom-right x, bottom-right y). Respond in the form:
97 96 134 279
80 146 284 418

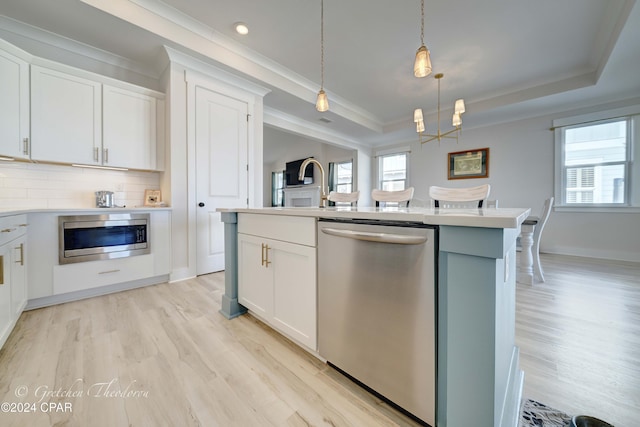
269 241 317 350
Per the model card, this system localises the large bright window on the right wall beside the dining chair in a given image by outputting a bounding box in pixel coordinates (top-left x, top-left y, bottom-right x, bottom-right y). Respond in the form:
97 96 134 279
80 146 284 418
554 108 638 208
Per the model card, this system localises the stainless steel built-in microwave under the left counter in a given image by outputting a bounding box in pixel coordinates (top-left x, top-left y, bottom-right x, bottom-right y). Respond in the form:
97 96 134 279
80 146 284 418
58 213 151 264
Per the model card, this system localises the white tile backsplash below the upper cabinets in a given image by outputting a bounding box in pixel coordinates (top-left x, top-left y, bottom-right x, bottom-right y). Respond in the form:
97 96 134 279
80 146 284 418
0 162 161 210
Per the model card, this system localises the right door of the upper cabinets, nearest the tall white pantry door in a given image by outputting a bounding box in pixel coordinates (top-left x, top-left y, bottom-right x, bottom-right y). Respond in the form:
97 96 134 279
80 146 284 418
102 85 157 169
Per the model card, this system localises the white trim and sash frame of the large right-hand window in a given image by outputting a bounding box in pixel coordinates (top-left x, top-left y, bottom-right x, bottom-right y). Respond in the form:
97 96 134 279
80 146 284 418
551 105 640 213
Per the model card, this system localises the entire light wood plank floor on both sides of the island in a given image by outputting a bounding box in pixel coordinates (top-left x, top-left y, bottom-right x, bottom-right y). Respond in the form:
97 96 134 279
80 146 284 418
0 255 640 427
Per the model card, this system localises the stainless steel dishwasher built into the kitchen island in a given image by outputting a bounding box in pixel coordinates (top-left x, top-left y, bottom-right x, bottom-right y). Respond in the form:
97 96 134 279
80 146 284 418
318 219 437 426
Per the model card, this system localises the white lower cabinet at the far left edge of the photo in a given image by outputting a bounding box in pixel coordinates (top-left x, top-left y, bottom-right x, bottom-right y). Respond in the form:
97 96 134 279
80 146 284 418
0 215 27 347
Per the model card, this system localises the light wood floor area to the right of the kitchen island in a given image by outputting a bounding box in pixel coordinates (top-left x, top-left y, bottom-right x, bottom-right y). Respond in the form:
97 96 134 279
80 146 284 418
516 254 640 427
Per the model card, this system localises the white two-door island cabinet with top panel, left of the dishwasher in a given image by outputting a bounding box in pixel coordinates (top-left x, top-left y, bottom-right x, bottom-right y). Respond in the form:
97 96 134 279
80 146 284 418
238 214 317 351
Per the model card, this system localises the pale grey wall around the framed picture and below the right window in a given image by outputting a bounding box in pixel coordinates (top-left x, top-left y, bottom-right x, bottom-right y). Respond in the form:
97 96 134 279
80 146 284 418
410 105 640 262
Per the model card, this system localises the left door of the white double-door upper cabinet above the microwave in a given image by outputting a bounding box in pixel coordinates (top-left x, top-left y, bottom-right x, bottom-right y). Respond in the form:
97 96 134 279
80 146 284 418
31 65 102 164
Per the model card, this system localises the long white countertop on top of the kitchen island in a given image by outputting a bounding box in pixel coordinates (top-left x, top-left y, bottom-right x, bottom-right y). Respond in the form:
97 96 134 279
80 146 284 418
218 207 531 228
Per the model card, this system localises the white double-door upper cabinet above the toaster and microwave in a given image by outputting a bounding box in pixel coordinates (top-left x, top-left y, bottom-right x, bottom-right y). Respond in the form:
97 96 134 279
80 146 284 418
31 65 164 170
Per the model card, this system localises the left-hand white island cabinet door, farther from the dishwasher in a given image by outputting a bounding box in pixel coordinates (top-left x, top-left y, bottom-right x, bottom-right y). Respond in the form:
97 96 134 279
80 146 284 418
238 234 273 322
